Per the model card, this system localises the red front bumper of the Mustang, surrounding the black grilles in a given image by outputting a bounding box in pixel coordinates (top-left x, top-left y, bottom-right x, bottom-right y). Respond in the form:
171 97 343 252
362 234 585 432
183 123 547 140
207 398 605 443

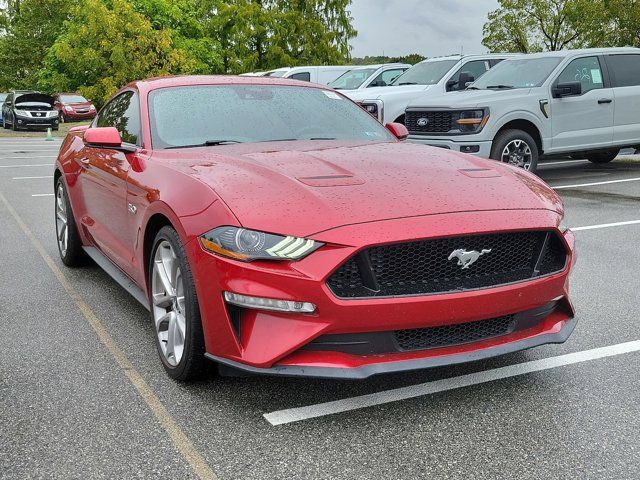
188 210 575 378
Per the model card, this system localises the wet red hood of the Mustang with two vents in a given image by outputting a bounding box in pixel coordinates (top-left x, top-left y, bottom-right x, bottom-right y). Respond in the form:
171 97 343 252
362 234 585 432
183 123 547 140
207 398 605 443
154 141 562 236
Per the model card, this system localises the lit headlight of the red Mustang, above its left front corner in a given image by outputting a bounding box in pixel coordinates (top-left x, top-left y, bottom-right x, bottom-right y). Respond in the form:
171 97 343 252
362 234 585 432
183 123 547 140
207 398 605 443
199 227 324 262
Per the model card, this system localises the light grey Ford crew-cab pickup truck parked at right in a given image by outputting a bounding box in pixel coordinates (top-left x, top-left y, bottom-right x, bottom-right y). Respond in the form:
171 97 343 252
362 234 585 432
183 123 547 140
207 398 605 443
406 48 640 171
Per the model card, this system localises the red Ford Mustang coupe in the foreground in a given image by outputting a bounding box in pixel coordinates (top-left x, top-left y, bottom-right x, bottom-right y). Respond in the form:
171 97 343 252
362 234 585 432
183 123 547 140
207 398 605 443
55 76 576 380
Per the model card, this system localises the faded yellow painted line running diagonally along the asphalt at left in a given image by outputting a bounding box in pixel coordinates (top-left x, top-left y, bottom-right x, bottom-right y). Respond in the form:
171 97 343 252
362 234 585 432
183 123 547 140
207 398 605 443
0 193 218 480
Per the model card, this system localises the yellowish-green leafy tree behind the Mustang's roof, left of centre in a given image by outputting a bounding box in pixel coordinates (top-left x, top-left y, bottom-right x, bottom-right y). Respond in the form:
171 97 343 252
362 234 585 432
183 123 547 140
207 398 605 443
40 0 198 104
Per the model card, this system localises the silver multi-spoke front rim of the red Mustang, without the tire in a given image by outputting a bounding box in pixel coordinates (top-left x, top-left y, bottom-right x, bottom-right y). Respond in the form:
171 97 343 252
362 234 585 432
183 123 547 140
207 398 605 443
151 240 186 367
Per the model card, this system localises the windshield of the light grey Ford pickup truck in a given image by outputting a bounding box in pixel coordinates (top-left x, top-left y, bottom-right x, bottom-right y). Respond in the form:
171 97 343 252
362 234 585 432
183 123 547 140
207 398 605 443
470 57 562 89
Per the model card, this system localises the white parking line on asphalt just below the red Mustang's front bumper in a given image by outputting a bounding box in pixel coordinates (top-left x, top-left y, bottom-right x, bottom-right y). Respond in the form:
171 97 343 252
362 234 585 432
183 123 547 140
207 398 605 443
263 340 640 425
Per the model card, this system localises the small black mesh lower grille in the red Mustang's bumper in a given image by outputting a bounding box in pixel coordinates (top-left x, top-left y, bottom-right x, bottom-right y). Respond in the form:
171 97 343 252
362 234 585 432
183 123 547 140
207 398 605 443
394 315 516 351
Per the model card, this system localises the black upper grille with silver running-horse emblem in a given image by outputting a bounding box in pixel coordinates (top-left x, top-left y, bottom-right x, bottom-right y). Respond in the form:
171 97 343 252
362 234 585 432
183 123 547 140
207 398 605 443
327 231 567 298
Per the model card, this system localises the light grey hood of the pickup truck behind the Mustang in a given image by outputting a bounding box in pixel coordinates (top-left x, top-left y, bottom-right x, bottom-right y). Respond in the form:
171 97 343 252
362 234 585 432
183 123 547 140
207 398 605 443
409 88 531 108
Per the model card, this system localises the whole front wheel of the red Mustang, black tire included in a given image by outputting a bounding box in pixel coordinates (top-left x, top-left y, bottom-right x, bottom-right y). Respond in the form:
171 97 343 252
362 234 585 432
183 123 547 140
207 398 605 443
148 226 207 382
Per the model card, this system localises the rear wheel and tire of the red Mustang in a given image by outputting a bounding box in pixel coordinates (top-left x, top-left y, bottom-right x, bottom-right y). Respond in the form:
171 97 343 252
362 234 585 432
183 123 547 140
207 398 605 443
54 177 86 267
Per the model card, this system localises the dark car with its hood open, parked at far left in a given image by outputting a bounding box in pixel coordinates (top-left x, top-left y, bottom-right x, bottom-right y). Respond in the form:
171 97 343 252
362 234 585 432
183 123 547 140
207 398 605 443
2 90 59 130
